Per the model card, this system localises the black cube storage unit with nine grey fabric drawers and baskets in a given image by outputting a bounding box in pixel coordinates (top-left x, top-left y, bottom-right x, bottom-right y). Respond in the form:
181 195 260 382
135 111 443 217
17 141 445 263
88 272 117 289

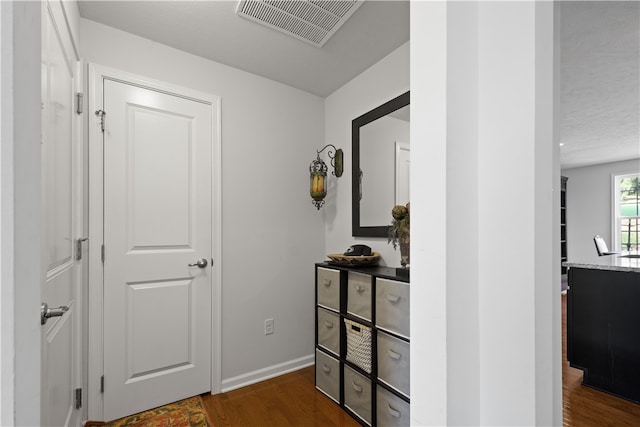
315 263 410 427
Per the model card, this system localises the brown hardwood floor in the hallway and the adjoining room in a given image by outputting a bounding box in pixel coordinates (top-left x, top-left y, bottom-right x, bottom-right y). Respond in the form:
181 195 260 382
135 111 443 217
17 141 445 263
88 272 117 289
203 295 640 427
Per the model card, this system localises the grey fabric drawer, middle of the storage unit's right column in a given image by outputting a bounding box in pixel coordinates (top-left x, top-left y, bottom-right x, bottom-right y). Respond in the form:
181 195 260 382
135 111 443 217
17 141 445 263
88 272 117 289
378 331 410 397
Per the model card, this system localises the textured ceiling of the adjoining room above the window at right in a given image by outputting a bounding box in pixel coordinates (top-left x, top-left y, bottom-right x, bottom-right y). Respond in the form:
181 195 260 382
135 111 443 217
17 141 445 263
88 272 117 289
560 1 640 168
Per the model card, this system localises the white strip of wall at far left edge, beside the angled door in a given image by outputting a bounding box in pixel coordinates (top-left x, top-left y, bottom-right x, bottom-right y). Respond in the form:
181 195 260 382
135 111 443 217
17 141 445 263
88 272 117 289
0 2 41 425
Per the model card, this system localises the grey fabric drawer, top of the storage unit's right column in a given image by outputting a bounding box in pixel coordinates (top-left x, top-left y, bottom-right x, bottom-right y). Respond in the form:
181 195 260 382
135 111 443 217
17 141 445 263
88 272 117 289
376 278 409 338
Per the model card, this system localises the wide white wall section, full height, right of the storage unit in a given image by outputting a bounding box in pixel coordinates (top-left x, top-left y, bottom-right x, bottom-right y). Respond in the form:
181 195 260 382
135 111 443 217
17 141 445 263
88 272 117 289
411 2 562 426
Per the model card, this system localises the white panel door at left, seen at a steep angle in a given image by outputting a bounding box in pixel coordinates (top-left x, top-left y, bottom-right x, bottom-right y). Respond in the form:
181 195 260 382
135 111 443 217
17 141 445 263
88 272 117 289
40 2 81 426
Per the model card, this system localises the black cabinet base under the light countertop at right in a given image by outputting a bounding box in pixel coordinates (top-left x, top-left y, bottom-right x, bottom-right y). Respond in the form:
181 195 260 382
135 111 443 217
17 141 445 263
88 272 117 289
567 267 640 402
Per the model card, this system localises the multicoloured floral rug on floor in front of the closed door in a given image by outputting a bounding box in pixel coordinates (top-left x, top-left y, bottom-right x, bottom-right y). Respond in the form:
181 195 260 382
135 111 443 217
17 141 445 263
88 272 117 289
85 396 212 427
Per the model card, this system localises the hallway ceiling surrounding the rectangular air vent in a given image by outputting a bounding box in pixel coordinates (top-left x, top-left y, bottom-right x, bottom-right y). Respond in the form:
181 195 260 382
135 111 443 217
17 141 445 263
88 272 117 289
79 0 409 97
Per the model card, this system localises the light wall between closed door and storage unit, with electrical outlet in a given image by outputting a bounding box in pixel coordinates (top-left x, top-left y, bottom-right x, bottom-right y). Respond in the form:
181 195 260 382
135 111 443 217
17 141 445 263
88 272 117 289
80 19 328 389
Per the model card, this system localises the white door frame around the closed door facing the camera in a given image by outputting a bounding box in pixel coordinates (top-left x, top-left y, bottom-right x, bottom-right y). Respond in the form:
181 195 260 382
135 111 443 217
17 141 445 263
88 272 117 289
87 64 222 420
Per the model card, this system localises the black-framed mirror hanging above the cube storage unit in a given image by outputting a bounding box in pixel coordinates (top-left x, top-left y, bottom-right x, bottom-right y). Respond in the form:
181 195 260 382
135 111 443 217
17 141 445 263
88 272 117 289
351 91 410 237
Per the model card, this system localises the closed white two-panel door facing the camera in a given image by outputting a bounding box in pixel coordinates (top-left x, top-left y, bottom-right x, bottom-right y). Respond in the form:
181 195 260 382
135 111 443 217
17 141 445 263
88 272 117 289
103 79 212 420
